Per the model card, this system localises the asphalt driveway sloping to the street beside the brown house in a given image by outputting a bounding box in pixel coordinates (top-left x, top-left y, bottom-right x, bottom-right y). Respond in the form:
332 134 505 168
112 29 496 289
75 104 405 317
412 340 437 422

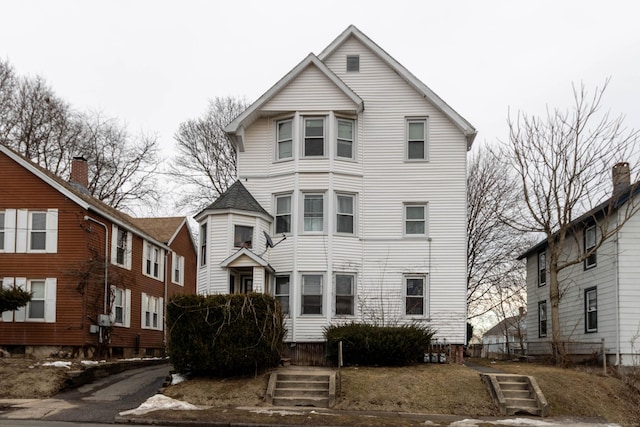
0 364 171 426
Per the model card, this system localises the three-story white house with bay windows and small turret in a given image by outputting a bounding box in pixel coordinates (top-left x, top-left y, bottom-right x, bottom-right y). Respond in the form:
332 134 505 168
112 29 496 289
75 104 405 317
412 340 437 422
196 26 476 362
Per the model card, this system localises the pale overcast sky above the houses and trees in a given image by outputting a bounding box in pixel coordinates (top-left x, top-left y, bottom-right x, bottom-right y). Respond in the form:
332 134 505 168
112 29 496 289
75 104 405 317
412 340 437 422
0 0 640 191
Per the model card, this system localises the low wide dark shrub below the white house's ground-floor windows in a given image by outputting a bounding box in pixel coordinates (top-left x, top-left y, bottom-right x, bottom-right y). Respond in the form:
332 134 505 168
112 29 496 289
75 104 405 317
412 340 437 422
324 323 434 366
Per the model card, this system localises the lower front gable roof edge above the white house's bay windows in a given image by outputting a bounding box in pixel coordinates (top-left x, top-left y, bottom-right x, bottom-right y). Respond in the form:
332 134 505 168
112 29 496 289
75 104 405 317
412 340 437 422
224 53 364 151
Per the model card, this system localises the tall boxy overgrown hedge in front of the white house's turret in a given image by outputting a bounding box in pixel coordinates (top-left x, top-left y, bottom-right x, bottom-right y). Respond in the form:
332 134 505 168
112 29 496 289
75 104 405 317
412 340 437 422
167 293 286 377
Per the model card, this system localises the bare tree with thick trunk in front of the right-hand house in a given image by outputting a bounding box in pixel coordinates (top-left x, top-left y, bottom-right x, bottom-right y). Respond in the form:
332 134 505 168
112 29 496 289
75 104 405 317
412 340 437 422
500 81 639 363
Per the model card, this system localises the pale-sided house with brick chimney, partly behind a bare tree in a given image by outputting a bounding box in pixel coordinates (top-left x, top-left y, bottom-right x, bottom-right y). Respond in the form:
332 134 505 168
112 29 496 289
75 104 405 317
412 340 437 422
520 163 640 365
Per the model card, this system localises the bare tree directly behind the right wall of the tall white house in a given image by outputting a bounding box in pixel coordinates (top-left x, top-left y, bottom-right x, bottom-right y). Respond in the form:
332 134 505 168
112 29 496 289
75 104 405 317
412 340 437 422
467 147 532 319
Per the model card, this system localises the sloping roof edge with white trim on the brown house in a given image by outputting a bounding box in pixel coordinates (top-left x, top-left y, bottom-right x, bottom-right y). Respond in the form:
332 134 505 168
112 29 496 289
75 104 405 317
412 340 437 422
0 144 186 249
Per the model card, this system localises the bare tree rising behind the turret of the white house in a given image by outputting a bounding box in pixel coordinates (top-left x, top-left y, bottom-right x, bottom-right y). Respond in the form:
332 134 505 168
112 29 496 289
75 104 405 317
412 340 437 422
172 97 248 209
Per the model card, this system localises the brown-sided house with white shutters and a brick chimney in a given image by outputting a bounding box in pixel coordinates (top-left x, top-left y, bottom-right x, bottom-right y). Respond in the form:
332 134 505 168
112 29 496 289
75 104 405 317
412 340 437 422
0 145 196 357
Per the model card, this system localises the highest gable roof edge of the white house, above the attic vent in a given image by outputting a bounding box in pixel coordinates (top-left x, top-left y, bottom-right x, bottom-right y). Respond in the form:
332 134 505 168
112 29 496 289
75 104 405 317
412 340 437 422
318 25 478 149
